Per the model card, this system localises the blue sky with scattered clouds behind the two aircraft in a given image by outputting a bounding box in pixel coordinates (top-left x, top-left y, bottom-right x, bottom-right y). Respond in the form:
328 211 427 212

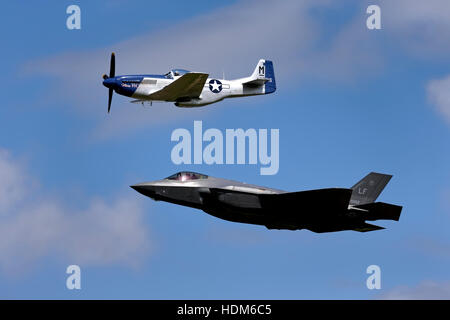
0 0 450 299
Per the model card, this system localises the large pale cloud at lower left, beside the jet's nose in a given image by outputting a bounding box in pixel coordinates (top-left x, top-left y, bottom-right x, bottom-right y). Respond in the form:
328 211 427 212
0 149 152 273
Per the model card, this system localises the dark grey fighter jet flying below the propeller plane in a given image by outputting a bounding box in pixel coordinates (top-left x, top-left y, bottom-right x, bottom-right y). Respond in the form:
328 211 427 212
131 171 402 232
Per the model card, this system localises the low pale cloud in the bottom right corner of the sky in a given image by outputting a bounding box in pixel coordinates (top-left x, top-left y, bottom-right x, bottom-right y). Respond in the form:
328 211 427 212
380 281 450 300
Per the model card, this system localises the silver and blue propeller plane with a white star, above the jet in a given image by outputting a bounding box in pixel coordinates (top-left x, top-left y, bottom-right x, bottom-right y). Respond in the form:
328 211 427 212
103 52 276 112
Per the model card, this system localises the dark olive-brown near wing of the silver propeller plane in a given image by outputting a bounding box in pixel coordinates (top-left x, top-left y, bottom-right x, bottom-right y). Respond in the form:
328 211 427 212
147 72 208 101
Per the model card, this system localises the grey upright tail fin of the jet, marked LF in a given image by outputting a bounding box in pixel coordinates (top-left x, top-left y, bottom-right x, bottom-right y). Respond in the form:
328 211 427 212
350 172 392 206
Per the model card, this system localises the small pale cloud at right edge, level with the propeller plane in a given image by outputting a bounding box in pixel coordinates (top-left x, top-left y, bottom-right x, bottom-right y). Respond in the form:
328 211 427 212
427 75 450 123
